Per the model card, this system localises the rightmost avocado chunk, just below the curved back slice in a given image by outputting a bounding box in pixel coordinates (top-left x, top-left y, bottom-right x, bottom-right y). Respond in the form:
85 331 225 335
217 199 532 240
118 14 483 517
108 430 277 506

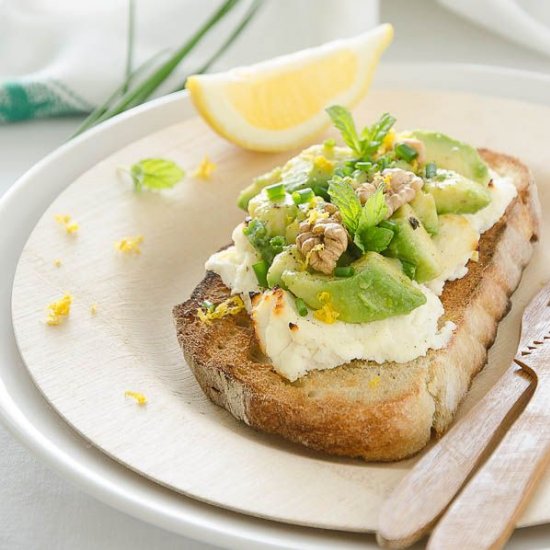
424 168 491 214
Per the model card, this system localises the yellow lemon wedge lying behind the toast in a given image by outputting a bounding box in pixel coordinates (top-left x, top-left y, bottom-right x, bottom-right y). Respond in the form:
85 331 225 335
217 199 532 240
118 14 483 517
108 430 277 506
187 24 393 151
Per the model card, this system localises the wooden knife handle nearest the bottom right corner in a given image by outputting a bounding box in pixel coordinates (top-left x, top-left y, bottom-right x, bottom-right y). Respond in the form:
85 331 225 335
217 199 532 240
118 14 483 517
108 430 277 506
428 386 550 550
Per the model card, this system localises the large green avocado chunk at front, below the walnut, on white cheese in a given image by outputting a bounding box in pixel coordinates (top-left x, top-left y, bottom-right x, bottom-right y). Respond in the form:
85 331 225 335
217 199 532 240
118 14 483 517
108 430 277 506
282 252 426 323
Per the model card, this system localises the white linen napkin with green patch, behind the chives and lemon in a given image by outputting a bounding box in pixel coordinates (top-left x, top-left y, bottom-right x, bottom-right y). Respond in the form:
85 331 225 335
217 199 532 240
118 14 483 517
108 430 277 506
0 0 378 122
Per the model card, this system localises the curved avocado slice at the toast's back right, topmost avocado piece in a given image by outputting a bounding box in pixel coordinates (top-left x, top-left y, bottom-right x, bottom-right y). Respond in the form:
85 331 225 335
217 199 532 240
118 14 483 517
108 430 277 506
407 130 491 185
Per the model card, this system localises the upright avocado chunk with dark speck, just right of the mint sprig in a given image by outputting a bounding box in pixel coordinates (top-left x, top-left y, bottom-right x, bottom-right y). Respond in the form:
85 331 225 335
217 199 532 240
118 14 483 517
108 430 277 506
386 204 441 283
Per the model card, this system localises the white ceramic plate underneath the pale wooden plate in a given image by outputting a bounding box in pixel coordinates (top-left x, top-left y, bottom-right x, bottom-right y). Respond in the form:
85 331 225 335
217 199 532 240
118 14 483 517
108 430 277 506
0 66 549 548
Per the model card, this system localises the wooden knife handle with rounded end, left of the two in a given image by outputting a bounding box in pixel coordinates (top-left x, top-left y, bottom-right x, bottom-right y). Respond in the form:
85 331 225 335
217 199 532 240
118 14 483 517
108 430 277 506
377 364 534 548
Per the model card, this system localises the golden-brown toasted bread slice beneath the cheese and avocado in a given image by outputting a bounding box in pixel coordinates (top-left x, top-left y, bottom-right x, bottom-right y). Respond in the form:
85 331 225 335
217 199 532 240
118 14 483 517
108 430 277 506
173 149 540 461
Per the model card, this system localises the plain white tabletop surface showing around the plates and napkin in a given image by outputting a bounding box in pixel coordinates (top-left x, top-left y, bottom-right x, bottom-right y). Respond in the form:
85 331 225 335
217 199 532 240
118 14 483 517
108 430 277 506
0 0 550 550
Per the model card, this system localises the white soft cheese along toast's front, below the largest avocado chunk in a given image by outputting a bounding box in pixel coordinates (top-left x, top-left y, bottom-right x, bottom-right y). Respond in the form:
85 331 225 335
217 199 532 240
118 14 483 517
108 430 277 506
252 285 455 382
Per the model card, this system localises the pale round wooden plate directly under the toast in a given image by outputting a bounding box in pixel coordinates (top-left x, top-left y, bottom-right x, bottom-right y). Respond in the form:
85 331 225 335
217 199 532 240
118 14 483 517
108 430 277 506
12 91 550 532
